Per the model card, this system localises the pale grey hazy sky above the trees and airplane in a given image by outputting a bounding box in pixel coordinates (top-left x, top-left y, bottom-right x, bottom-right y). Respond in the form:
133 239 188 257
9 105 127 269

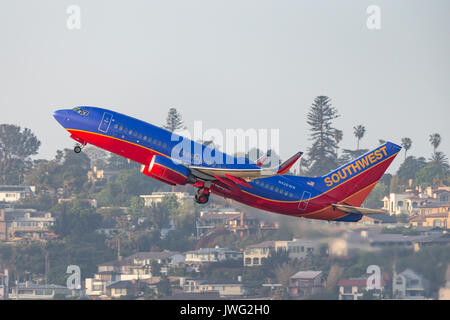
0 0 450 174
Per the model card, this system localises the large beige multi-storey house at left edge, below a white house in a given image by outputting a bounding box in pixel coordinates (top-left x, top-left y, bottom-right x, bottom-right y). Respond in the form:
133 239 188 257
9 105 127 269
0 208 56 241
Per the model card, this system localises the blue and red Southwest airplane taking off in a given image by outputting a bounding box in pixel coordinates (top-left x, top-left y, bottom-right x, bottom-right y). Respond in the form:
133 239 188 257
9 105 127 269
53 106 401 222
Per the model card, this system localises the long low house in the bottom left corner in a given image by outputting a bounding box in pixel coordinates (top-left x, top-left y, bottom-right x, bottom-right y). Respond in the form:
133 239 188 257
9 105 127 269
9 281 82 300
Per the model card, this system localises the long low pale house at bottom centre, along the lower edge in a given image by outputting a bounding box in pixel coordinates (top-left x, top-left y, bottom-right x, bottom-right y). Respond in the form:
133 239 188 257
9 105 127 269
180 279 247 297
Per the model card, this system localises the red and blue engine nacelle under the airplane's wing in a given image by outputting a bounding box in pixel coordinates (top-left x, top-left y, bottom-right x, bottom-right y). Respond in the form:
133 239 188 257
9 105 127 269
142 156 191 185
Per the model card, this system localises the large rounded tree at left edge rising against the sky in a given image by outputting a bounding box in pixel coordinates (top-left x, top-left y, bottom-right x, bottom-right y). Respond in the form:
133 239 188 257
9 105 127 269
0 124 41 184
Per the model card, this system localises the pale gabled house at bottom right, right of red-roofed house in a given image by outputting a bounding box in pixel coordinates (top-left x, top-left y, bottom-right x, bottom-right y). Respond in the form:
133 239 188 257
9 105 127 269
392 269 428 299
